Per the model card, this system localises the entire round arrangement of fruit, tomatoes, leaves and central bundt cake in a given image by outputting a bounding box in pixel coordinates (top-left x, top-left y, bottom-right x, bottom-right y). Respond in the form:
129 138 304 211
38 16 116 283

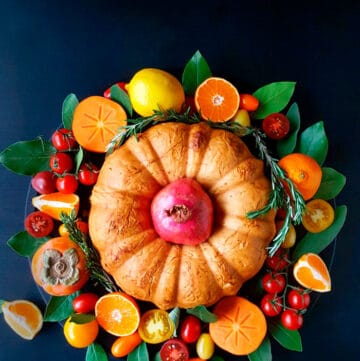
0 51 346 361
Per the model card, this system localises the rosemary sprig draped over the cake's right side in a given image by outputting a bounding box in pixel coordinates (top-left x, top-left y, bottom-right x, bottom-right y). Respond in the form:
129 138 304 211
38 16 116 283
247 129 305 256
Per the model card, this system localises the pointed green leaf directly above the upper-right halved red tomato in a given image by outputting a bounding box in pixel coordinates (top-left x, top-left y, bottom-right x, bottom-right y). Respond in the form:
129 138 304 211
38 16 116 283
253 81 296 119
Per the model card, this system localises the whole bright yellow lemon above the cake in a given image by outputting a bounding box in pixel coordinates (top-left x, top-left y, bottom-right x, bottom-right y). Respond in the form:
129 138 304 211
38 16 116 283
126 68 185 117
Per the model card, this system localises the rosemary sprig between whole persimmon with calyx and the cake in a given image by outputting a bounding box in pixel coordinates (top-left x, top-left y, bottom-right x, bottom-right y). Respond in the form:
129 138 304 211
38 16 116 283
60 212 119 292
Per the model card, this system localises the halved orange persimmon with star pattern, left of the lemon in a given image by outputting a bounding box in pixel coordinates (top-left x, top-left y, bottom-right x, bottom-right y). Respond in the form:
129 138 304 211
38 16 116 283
72 96 127 153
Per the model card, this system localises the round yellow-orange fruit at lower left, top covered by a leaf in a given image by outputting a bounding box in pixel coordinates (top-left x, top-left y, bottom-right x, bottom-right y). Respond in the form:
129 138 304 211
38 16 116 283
64 315 99 348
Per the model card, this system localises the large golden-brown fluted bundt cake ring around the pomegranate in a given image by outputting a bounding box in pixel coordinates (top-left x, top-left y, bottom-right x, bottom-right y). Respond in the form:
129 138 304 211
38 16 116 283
89 123 275 309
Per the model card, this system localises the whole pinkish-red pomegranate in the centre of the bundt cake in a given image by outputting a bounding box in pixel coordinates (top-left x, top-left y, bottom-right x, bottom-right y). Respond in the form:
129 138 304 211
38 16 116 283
151 178 214 245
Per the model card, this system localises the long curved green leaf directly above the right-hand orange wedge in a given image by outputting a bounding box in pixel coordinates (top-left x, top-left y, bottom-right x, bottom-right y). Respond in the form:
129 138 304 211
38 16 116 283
292 206 347 261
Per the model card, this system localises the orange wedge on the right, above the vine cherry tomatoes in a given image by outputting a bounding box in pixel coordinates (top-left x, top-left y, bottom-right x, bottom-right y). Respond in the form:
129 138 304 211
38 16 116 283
293 253 331 292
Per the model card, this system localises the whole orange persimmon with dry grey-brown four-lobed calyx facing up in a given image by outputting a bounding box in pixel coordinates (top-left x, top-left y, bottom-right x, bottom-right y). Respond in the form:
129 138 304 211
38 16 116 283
31 237 89 296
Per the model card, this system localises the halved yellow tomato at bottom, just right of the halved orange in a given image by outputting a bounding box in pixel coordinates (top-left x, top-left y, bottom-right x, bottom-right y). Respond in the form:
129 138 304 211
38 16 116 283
138 309 175 344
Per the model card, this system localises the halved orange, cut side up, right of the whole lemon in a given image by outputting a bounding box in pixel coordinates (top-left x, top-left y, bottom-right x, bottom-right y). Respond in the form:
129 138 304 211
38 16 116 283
195 77 240 122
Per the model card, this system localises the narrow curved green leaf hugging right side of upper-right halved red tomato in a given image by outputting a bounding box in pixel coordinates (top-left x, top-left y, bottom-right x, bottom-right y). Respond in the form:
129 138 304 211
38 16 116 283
276 103 300 158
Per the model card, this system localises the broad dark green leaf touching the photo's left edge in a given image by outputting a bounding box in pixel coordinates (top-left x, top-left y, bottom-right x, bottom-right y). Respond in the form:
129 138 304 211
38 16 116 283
0 137 55 175
